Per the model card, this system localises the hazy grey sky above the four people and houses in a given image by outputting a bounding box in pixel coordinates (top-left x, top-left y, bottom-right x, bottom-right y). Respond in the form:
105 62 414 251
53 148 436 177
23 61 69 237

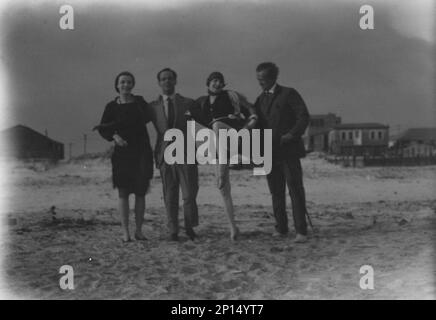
0 0 436 155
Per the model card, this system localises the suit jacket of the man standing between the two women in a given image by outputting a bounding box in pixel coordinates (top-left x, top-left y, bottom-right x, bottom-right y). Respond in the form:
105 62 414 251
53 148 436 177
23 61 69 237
148 93 195 168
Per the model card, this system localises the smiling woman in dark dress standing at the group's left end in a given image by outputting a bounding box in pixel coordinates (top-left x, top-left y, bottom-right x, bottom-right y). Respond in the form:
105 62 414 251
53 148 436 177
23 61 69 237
96 72 153 242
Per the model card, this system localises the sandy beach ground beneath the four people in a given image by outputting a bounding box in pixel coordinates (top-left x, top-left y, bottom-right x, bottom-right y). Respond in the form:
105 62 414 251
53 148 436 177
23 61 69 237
1 155 436 299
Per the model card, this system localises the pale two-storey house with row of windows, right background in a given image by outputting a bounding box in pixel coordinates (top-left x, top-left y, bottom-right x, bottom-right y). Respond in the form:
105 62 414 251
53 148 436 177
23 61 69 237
328 123 389 156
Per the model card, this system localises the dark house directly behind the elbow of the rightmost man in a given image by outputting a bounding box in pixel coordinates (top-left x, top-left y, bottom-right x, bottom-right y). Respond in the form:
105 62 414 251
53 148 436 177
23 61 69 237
303 113 341 152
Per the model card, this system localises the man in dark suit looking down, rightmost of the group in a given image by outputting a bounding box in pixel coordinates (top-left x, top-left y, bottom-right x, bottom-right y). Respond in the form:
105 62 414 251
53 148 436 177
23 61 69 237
255 62 310 242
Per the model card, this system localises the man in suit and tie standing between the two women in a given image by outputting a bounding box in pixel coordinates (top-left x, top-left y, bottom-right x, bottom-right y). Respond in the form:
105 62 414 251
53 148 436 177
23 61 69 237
149 68 198 241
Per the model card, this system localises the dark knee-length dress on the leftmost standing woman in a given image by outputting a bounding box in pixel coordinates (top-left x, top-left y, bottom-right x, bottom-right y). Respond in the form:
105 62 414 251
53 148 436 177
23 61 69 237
98 96 153 195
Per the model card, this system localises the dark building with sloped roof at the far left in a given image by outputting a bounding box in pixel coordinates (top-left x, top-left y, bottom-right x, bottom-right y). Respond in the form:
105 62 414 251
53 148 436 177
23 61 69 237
0 125 64 160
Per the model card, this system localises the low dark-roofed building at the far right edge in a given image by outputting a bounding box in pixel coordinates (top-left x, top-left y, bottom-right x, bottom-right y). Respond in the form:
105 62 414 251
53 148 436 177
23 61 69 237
391 128 436 158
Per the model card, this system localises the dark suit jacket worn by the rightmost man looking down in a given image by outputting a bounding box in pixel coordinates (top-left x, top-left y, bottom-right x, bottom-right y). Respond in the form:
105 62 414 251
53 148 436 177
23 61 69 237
254 84 310 162
